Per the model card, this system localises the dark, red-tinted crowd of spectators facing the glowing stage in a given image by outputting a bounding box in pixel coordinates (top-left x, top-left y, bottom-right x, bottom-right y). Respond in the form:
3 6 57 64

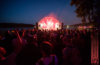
0 29 91 65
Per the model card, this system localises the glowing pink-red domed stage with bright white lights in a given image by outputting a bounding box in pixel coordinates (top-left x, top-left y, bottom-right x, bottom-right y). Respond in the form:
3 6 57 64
38 16 62 30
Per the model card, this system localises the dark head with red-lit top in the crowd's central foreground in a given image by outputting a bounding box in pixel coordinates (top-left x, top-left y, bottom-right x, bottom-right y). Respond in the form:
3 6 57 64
41 41 53 56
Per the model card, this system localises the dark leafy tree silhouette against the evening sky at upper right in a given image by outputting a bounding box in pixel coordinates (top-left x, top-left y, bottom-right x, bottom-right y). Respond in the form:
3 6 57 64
70 0 100 23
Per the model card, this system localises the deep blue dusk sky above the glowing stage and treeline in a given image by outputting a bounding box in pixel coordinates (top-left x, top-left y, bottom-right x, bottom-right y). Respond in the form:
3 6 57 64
0 0 81 25
